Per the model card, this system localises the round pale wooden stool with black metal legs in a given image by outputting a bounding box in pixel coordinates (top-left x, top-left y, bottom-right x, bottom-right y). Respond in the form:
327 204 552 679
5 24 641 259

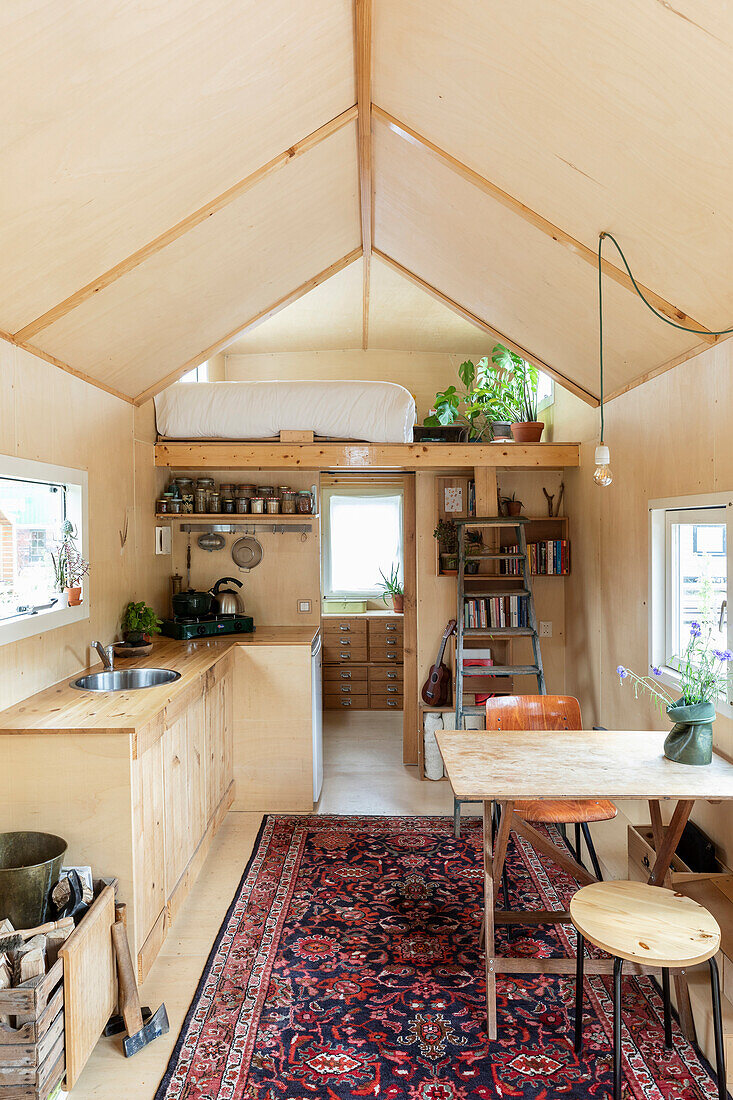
570 882 727 1100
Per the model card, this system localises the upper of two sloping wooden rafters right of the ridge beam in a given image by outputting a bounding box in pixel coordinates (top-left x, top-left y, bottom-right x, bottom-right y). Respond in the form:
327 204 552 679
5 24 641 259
372 103 718 343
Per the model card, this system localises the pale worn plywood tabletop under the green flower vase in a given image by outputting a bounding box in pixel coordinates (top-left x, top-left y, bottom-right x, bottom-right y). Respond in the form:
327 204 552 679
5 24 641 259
437 729 733 802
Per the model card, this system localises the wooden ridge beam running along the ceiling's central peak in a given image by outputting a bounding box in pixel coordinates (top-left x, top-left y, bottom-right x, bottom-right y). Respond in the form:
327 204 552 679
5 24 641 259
354 0 373 351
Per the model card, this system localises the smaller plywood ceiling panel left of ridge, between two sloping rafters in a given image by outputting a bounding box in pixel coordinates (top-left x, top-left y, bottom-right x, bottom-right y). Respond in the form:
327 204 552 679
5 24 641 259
36 124 359 396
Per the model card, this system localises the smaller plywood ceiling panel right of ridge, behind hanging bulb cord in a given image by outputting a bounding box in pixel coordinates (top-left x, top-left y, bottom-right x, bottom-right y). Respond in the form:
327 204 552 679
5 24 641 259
374 124 698 393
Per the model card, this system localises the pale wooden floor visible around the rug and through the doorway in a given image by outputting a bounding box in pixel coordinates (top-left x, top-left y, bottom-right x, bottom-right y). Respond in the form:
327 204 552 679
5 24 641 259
72 711 478 1100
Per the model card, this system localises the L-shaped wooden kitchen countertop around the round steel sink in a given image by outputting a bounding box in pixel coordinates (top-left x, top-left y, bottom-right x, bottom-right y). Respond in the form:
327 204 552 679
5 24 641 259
0 626 318 735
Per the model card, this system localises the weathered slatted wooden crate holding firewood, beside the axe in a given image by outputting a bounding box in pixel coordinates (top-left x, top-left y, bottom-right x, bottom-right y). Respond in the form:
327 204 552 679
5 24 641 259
0 958 66 1100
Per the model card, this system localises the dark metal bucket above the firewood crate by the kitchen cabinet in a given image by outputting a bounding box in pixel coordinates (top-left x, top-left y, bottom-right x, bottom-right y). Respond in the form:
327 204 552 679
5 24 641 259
0 833 67 928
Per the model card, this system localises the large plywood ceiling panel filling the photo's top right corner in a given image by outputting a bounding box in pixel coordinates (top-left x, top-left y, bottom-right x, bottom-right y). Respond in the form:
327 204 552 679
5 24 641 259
374 0 733 328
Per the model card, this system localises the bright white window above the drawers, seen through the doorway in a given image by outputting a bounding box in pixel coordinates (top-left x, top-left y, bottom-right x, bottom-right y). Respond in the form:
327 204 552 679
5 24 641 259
322 485 404 600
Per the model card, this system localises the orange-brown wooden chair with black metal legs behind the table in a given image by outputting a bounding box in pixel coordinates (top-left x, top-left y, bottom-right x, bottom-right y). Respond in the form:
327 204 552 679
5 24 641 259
486 695 619 893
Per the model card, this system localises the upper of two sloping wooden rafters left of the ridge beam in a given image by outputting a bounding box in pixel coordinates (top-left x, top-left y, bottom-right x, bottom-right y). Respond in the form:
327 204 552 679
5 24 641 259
14 105 359 347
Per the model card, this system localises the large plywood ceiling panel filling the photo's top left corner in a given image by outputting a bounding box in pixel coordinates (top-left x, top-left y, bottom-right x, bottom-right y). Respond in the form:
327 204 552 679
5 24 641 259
0 0 355 332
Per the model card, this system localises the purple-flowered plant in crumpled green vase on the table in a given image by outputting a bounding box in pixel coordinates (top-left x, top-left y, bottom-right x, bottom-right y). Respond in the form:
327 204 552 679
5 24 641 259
616 623 733 765
